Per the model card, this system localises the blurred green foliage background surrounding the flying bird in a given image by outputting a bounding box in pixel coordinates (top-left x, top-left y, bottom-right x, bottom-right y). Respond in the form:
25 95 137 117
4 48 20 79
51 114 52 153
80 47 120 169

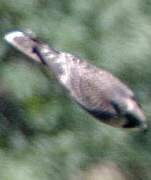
0 0 151 180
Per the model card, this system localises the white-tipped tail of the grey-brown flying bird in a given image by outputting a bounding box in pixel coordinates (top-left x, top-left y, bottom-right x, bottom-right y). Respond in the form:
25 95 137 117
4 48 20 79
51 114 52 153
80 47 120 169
4 31 58 63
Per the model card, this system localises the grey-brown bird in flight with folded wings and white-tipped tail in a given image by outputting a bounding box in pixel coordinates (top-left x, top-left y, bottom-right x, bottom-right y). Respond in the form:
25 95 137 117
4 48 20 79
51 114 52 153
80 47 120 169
4 31 147 130
